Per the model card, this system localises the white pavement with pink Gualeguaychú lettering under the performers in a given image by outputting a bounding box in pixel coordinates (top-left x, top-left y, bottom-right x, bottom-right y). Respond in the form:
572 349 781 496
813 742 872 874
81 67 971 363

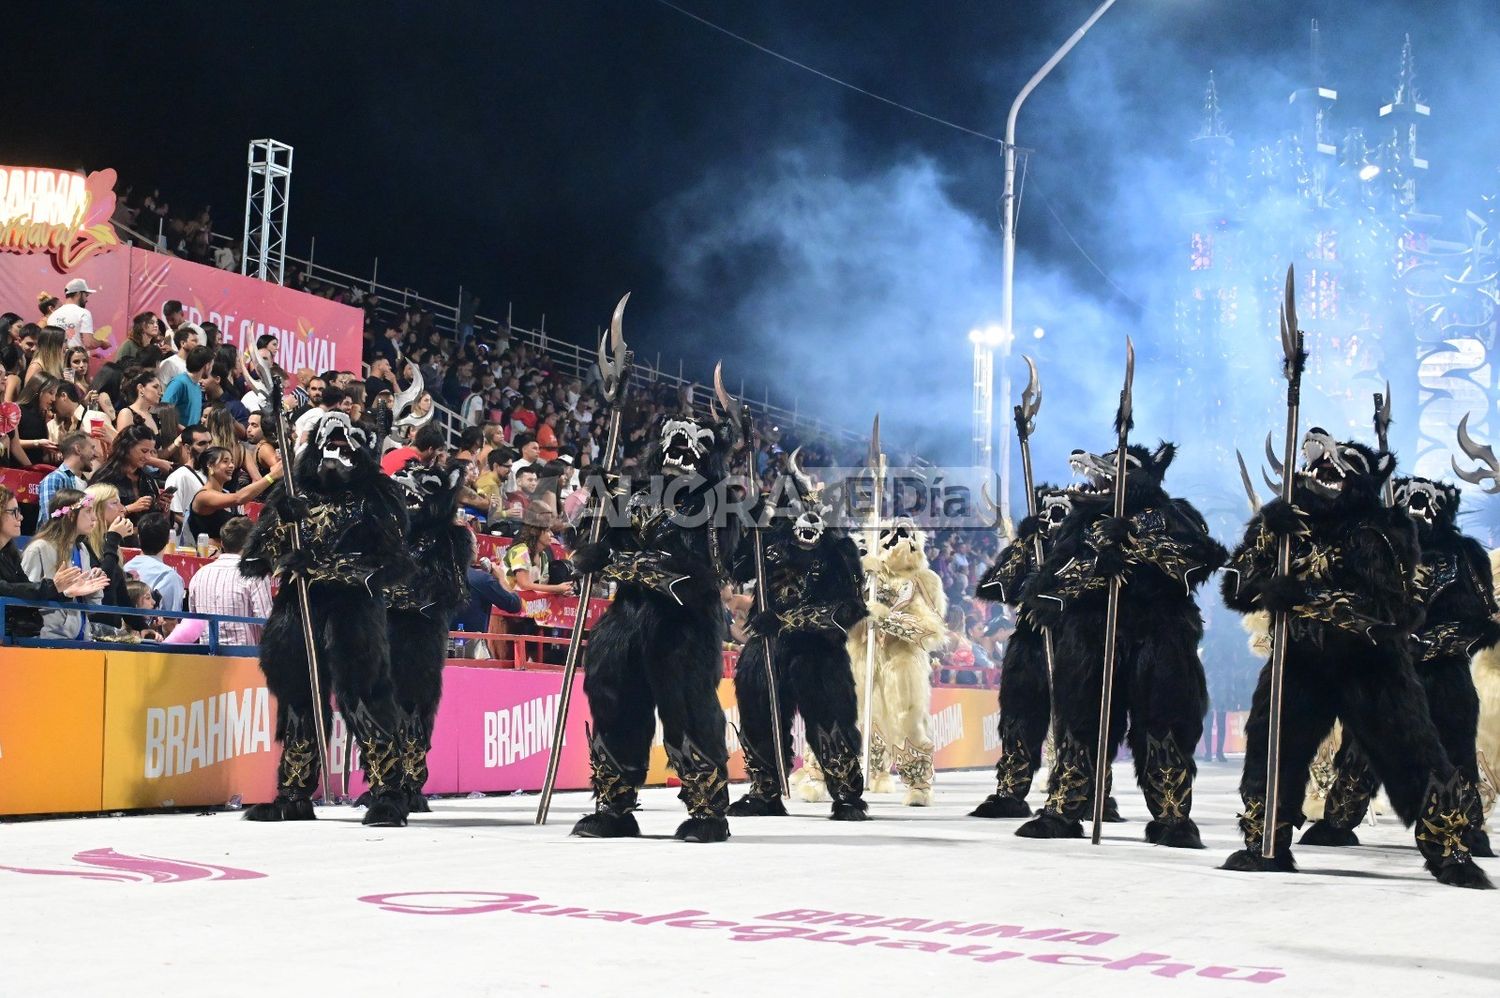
0 762 1500 998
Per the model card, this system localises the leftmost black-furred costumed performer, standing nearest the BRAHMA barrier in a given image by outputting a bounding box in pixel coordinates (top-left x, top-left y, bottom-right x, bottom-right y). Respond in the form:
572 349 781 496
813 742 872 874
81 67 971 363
240 411 414 825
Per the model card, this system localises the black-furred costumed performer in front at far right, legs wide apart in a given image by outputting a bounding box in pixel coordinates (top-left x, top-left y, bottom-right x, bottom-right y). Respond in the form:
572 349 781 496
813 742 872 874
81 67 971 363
1223 428 1490 887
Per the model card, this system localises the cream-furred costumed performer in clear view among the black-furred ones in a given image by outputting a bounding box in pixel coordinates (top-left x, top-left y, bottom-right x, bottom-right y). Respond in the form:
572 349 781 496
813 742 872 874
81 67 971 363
849 521 948 807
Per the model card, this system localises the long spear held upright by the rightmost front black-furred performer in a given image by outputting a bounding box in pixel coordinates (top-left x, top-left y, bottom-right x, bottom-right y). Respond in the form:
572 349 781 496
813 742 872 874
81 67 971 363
1260 267 1307 860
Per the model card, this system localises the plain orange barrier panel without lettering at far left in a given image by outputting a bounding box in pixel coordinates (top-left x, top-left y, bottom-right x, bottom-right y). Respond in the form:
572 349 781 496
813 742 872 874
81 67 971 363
0 648 105 815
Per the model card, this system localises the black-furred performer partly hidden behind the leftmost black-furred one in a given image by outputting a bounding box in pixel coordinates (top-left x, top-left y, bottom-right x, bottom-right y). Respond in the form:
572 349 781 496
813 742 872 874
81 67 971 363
386 462 474 812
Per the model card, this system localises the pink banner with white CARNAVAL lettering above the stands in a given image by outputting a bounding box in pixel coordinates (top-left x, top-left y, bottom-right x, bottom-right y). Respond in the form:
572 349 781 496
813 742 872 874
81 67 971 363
125 249 365 372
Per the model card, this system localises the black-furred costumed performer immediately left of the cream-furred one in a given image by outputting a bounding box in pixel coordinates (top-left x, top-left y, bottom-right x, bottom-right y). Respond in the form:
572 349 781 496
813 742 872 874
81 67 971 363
729 471 869 821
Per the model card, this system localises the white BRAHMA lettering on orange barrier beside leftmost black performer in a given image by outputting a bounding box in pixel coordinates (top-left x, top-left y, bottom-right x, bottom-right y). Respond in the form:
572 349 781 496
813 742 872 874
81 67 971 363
146 686 272 780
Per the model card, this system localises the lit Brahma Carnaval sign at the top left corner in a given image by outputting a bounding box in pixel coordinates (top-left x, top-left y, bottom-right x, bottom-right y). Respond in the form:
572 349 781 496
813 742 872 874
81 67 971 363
0 167 120 272
